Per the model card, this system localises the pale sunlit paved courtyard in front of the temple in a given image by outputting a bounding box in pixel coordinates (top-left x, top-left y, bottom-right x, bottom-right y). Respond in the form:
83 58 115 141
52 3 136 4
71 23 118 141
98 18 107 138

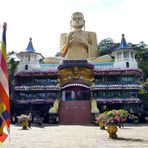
4 124 148 148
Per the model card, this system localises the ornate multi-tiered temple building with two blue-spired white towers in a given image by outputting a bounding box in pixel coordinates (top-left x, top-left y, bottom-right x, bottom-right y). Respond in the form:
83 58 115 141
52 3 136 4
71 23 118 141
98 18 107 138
12 36 142 124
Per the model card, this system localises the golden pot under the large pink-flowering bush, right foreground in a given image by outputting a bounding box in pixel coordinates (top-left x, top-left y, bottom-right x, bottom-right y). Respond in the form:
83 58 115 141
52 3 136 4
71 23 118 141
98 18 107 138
107 125 118 139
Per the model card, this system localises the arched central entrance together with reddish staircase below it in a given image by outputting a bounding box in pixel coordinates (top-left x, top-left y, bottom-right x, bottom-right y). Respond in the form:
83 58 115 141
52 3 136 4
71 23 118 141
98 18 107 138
59 84 92 125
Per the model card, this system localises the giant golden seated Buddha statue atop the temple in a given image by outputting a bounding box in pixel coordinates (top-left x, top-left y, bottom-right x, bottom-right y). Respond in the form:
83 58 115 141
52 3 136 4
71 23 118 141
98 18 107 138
45 12 112 63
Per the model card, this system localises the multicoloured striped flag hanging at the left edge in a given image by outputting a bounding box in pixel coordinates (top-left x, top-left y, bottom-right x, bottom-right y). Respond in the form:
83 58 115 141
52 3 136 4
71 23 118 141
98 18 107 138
0 23 10 143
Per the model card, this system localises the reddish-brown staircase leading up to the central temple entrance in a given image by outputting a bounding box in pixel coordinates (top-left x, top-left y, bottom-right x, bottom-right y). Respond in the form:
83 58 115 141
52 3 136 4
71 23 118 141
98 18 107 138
59 100 92 125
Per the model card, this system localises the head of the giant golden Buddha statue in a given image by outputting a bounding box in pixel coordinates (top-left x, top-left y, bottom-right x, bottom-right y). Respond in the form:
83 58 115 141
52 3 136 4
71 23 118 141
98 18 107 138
70 12 85 30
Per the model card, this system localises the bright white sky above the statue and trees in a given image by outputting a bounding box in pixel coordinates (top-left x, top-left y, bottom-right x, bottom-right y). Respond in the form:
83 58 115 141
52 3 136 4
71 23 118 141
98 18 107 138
0 0 148 57
